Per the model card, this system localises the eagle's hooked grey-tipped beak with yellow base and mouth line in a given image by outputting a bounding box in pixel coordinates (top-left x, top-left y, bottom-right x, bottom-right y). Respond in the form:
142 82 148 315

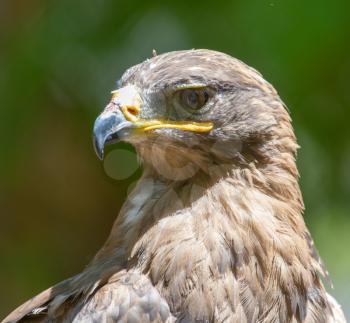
93 85 213 160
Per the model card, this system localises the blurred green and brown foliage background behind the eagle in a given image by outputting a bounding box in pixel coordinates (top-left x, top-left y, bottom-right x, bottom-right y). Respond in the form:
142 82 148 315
0 0 350 317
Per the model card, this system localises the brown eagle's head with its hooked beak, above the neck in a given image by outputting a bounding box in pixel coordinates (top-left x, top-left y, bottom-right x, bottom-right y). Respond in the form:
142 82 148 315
94 50 296 179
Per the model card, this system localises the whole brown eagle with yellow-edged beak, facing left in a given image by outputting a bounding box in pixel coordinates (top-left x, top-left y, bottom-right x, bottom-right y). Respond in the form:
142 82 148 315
4 50 345 323
